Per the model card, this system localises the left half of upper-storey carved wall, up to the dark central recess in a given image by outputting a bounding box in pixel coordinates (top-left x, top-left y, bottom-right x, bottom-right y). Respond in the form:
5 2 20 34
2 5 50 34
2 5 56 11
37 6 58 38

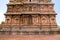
7 5 28 12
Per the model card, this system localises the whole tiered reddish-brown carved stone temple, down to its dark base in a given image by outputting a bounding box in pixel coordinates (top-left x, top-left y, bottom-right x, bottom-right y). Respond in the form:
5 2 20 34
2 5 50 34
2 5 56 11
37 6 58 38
0 0 60 35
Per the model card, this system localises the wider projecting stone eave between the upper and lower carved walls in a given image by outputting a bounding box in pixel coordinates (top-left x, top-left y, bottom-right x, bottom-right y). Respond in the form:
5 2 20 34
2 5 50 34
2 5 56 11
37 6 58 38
4 12 57 15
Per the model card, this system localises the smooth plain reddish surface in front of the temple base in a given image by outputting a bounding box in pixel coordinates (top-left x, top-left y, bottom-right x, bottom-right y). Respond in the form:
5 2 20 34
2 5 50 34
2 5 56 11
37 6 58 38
0 35 60 40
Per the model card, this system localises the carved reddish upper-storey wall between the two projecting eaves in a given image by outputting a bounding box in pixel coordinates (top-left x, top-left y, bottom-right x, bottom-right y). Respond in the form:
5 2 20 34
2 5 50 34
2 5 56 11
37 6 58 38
7 4 54 12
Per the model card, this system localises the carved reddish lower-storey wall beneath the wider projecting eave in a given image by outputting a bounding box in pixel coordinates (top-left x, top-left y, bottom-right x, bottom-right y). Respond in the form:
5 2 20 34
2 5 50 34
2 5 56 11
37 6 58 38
6 15 56 27
